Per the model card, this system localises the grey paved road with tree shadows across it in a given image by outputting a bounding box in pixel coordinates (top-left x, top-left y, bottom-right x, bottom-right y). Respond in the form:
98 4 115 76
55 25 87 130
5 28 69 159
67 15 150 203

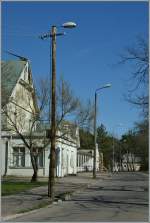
9 173 148 222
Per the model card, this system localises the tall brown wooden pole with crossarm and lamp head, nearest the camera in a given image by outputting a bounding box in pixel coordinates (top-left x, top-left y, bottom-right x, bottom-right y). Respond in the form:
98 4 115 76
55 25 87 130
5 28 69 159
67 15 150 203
40 22 76 200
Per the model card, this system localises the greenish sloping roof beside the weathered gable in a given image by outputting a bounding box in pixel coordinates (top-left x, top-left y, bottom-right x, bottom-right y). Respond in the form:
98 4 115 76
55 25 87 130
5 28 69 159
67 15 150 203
1 60 27 107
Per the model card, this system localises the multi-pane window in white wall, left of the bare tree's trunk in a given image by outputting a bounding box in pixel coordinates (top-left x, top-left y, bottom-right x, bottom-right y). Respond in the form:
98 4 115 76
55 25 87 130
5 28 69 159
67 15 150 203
13 147 25 167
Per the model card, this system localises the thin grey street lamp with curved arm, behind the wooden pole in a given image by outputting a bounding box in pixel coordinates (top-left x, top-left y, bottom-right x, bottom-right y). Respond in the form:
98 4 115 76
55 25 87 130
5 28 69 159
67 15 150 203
93 84 111 178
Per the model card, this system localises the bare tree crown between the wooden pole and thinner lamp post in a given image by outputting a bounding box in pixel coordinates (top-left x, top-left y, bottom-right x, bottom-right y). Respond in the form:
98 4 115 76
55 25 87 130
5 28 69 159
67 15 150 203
56 77 94 137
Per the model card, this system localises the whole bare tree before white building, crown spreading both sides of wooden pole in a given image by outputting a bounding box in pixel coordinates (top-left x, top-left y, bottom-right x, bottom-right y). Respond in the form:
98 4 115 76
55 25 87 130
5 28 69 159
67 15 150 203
3 75 92 181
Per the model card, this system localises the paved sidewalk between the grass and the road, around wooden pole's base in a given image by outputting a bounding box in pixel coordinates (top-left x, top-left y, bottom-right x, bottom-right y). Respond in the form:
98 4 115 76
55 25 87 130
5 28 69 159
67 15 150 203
1 173 110 220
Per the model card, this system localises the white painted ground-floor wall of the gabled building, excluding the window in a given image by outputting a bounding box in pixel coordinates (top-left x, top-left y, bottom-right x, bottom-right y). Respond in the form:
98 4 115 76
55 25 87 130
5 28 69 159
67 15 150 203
2 134 77 177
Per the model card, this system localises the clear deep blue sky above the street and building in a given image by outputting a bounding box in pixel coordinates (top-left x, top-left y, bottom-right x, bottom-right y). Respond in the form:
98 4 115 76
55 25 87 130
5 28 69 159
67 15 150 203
2 1 148 135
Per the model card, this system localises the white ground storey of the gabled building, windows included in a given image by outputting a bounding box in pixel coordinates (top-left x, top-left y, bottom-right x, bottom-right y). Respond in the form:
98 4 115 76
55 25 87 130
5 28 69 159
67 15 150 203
1 128 79 177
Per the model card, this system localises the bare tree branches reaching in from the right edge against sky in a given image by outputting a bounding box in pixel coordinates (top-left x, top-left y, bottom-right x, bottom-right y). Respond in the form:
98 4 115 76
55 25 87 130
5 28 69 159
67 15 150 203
120 37 149 117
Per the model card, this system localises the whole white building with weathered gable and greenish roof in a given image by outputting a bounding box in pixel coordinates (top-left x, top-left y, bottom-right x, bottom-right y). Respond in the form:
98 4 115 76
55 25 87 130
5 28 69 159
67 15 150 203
1 60 80 177
